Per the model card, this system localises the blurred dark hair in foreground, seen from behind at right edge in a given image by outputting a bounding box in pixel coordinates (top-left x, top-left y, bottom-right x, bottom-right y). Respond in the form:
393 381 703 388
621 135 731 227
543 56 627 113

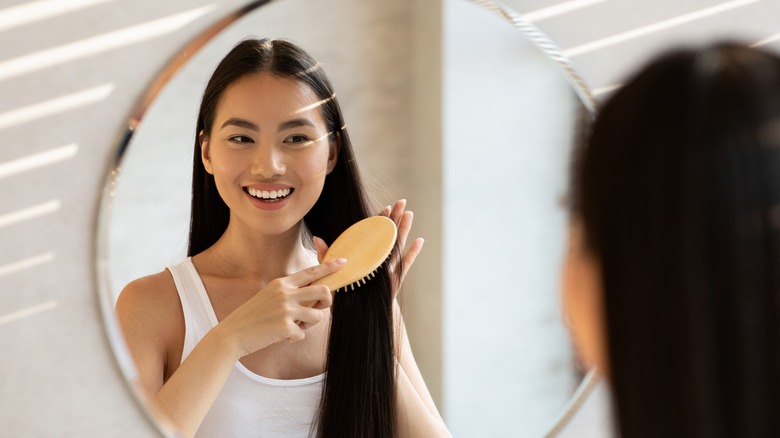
575 43 780 438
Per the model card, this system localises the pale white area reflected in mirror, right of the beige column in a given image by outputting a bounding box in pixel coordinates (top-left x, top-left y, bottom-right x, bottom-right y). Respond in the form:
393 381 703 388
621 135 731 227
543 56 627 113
442 2 588 437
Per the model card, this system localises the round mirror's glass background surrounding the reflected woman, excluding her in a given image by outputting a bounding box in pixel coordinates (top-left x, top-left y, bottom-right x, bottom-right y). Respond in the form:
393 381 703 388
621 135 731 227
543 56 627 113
99 0 588 436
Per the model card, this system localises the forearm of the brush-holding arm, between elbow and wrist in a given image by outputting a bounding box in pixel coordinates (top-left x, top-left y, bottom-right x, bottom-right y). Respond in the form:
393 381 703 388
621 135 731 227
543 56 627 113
154 330 238 437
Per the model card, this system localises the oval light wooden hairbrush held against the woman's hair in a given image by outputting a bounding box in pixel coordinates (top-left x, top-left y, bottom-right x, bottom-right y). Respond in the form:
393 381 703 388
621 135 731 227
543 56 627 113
312 216 397 293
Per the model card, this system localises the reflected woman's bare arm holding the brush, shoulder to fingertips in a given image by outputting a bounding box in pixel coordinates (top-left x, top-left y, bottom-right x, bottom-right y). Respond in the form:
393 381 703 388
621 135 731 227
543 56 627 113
116 262 343 437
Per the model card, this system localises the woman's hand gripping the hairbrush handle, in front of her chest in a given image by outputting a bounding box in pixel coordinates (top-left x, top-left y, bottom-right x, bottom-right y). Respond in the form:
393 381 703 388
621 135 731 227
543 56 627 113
217 259 346 360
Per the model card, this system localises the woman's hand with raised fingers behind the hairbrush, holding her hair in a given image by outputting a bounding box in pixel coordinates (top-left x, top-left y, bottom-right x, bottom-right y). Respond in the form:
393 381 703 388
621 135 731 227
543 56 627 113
314 199 425 298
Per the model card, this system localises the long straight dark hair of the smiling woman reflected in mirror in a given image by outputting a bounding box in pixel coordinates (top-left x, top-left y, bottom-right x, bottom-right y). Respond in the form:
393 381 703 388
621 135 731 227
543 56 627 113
188 39 395 438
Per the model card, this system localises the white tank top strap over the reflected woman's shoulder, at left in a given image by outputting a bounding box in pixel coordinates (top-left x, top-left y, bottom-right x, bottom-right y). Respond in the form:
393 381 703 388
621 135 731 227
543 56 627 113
167 257 217 361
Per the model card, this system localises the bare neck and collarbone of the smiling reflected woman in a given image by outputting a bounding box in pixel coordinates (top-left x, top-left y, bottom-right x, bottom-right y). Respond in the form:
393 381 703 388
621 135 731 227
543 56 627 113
206 222 316 283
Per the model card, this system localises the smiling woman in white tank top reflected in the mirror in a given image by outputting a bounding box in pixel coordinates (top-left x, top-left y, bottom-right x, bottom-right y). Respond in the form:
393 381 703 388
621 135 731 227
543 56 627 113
116 39 448 437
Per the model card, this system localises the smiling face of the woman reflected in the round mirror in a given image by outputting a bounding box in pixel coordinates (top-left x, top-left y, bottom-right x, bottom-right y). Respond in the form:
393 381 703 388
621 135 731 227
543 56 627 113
200 73 337 240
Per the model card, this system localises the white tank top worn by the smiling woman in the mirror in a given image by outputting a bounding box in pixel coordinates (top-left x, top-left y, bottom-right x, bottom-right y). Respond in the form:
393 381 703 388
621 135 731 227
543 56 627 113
168 258 325 438
